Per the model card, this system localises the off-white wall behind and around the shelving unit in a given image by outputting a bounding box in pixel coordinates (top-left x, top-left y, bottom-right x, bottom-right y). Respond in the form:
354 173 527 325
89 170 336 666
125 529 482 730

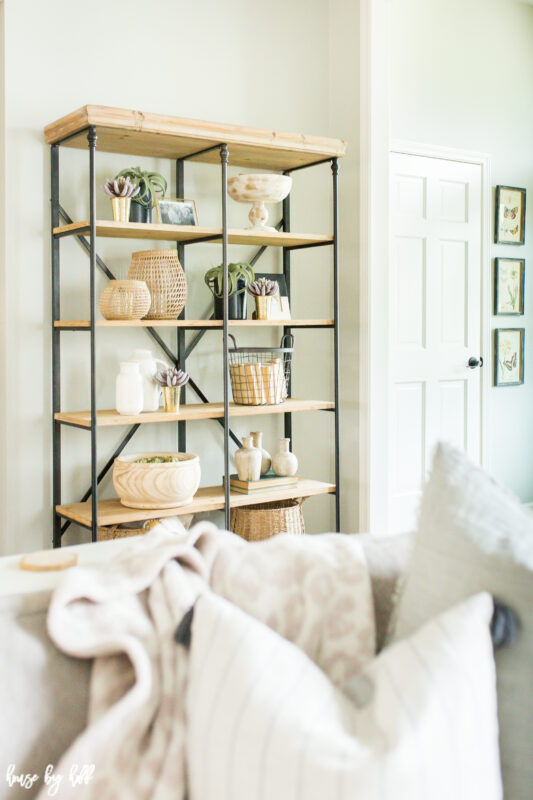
0 0 357 552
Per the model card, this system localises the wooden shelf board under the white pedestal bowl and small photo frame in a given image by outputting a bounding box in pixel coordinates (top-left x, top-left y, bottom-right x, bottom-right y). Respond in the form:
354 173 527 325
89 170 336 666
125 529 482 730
54 219 333 247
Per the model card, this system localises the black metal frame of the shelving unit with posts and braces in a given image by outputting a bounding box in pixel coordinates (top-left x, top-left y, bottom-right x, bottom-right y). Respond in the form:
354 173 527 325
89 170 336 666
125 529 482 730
50 131 341 547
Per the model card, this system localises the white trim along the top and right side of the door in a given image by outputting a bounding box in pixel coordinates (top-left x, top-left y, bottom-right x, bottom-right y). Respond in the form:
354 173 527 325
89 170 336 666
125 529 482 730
389 140 493 478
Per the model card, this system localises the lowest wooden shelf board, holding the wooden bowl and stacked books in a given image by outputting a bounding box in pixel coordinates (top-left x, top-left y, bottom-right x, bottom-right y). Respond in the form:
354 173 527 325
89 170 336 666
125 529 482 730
56 479 335 526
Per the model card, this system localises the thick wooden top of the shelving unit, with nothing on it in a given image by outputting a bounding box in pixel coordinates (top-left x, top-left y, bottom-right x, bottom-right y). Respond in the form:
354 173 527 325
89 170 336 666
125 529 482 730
44 105 346 170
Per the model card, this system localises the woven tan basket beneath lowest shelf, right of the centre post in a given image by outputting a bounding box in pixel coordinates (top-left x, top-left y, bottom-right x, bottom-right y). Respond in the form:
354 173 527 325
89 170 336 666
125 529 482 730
230 499 305 542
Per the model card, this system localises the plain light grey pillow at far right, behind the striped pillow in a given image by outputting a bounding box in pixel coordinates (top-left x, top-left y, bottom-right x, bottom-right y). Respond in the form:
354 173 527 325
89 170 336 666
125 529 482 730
395 445 533 800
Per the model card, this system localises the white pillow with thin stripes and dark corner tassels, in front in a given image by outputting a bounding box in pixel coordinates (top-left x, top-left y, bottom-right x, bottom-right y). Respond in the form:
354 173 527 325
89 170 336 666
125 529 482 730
185 593 502 800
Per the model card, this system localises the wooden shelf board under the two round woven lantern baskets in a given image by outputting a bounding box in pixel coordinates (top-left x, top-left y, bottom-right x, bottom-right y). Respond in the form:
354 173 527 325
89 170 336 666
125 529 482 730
54 319 334 330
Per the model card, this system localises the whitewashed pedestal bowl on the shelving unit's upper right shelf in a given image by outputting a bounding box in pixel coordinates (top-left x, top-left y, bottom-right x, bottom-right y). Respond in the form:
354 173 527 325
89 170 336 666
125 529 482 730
228 172 292 233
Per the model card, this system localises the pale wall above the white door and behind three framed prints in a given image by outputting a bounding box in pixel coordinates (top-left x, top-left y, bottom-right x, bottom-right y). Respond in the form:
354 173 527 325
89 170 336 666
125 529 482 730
390 0 533 502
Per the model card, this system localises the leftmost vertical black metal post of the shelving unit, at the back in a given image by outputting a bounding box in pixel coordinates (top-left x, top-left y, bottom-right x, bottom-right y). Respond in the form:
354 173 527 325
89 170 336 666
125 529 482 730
50 144 61 547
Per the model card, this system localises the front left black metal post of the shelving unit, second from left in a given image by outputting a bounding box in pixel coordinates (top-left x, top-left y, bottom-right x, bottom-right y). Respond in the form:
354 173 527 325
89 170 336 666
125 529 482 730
87 125 98 542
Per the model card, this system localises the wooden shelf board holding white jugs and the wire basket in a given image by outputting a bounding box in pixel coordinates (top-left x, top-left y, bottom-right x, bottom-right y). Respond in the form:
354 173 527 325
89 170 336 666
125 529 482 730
54 397 335 428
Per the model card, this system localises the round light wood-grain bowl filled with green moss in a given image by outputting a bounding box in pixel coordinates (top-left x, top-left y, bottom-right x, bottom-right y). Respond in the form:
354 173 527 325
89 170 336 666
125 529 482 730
113 452 200 508
